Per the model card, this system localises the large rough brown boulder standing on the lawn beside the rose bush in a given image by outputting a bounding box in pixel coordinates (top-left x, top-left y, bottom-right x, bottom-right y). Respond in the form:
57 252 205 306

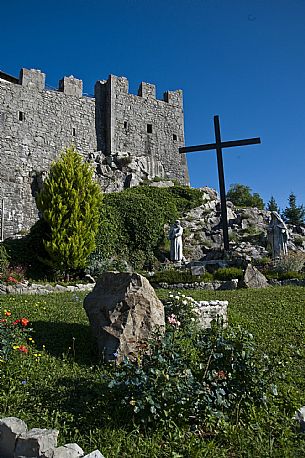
84 272 165 362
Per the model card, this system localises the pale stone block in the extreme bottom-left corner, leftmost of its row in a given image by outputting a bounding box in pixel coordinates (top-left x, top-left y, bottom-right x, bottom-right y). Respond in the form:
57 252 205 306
0 417 27 458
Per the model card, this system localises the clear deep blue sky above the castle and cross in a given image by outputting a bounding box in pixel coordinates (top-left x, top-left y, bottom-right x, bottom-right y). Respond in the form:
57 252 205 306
0 0 305 209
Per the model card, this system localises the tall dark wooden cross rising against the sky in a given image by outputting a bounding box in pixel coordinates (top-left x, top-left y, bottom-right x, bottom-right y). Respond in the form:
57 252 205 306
179 116 261 251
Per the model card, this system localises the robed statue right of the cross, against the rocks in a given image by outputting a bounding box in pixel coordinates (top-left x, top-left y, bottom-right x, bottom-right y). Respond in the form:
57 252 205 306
268 212 289 259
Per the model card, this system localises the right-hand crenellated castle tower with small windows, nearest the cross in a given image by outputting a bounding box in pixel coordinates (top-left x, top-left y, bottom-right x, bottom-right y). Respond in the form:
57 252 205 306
96 75 189 184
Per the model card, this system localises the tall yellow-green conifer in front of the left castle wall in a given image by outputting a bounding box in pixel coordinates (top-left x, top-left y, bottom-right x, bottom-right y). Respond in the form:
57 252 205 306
36 146 102 275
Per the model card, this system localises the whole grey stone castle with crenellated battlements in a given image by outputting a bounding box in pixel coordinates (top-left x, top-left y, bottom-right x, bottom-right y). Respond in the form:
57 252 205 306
0 68 189 239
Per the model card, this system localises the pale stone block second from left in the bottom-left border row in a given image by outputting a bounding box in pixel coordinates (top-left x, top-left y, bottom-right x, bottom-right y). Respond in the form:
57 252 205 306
14 428 59 458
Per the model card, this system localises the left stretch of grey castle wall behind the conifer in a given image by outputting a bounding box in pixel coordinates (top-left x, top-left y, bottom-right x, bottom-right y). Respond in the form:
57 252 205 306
0 70 96 237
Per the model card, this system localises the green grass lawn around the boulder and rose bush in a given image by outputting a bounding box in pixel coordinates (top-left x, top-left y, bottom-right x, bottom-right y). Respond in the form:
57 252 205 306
0 287 305 458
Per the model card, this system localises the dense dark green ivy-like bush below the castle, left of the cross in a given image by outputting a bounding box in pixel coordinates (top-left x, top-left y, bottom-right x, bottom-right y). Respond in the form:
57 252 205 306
96 185 202 270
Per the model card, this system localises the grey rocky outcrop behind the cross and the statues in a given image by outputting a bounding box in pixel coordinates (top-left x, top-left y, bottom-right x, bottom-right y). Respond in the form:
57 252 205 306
180 187 305 261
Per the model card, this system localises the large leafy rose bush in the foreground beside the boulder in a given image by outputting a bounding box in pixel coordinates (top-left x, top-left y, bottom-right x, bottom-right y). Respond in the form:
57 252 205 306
107 295 276 430
